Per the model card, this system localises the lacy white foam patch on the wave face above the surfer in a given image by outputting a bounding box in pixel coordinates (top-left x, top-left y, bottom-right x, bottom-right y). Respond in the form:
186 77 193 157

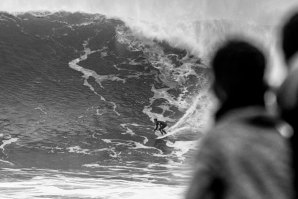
116 26 208 129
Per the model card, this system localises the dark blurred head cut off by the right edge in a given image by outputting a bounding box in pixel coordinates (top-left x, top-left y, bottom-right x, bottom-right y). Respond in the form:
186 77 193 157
281 12 298 63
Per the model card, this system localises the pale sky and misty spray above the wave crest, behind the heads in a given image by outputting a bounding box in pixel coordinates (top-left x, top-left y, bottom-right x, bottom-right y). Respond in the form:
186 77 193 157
0 0 298 84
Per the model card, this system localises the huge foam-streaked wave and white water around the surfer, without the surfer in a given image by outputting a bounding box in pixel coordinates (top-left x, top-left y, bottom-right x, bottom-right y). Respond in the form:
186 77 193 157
0 12 210 198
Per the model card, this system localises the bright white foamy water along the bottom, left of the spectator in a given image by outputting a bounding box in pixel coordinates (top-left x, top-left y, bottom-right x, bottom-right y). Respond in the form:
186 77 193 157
0 169 185 199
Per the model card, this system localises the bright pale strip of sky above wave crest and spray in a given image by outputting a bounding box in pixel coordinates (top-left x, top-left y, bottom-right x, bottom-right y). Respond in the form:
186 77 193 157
0 0 297 23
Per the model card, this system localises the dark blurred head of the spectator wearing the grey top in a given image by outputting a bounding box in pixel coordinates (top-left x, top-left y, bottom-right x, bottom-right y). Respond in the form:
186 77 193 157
211 39 266 106
